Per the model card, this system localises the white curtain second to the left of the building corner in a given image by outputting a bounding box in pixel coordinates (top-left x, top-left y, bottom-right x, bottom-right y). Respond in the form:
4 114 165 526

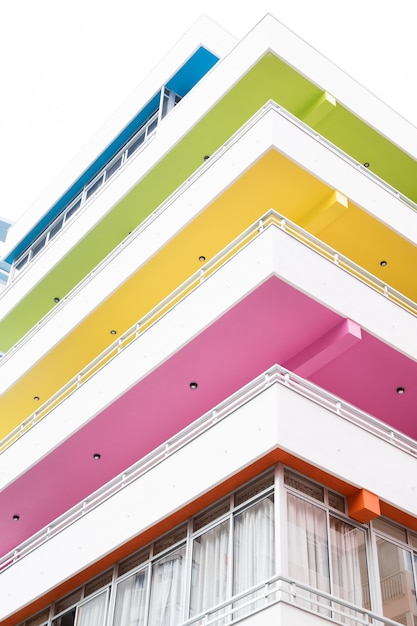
190 521 229 617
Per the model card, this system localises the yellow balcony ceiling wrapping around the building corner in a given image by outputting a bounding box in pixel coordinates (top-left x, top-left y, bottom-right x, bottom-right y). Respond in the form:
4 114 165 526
0 150 417 437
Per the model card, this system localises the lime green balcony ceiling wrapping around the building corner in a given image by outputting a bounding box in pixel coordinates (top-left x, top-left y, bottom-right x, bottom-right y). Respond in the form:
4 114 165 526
0 52 417 352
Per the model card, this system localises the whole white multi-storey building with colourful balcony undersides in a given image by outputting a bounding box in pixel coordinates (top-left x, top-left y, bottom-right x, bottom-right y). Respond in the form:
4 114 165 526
0 16 417 626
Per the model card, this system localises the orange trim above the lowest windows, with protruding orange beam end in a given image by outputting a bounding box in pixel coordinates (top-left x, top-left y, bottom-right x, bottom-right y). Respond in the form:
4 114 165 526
5 449 417 626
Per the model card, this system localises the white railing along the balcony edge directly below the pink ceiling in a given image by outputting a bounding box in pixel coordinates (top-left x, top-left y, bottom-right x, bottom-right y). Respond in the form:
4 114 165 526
0 365 417 572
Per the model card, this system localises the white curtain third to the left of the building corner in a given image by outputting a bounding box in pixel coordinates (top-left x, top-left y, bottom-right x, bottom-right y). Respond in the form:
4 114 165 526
148 547 185 626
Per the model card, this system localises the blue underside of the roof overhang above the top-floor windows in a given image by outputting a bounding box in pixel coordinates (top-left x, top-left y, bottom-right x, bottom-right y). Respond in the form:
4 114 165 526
4 47 219 263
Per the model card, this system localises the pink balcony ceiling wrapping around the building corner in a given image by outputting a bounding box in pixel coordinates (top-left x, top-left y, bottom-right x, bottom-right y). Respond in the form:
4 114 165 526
0 270 417 553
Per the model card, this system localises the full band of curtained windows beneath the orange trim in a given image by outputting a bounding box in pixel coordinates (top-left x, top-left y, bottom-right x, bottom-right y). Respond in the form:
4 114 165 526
22 466 417 626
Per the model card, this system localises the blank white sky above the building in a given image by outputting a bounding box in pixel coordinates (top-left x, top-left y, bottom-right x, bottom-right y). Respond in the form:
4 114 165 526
0 0 417 221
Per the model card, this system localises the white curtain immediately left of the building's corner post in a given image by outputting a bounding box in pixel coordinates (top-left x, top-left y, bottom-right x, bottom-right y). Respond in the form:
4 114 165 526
233 496 275 617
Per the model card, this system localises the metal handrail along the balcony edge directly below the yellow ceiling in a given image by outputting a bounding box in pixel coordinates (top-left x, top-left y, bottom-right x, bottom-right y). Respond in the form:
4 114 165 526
0 209 417 454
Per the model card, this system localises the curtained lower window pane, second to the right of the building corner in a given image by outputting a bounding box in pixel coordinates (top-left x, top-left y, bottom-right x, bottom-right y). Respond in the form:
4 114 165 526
330 517 371 616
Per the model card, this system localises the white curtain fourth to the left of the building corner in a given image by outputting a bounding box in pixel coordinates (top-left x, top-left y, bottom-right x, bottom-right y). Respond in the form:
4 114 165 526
113 570 148 626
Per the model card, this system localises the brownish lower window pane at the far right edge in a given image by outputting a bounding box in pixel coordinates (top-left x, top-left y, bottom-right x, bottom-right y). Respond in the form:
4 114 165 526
377 537 417 624
